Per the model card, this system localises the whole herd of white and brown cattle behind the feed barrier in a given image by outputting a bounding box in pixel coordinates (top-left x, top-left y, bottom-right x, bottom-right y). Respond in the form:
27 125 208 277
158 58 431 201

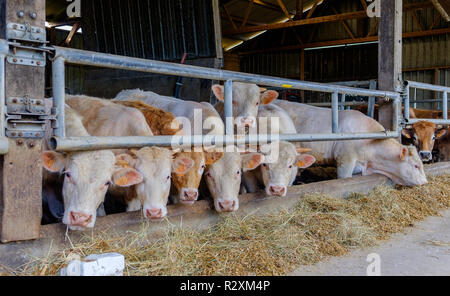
42 83 449 230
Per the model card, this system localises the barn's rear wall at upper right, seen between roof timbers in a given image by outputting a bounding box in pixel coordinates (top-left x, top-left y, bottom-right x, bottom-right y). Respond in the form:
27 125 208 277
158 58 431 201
239 0 450 104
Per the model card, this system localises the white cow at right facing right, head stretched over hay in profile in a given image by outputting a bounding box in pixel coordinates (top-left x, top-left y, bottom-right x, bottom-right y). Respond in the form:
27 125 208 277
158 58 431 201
275 101 427 186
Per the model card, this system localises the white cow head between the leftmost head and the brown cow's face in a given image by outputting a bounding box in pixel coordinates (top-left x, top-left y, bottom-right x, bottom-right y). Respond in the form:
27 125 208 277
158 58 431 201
117 147 194 219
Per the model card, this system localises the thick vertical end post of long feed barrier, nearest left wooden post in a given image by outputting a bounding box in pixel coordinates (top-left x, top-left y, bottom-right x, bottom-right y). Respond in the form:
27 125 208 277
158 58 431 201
52 57 66 138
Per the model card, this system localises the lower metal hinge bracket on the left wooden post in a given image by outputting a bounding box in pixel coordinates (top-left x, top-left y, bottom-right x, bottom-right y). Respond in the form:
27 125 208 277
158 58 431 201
6 97 56 139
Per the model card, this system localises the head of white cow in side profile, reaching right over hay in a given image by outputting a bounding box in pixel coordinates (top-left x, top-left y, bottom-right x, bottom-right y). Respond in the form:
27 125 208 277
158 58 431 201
363 139 428 186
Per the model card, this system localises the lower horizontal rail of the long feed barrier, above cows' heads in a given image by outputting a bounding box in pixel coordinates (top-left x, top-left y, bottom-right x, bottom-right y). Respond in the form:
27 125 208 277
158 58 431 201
49 132 400 152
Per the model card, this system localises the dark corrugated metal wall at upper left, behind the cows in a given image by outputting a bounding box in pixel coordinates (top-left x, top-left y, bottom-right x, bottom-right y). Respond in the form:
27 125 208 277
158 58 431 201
82 0 216 61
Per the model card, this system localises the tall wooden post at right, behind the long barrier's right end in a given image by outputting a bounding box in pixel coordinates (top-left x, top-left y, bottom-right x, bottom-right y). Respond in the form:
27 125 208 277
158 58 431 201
378 0 403 130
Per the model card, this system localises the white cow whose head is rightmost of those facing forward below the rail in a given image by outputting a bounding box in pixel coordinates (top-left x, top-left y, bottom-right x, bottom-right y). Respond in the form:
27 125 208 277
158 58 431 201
244 105 316 196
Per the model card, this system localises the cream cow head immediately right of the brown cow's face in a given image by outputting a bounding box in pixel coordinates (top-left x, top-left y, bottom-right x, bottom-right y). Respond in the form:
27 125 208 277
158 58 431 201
205 152 264 212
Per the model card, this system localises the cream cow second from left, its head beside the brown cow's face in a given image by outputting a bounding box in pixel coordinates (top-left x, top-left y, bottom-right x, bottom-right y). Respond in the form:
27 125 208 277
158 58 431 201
66 96 194 219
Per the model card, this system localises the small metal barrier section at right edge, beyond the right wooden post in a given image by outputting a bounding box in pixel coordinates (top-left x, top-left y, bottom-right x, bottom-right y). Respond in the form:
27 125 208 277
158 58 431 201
404 81 450 125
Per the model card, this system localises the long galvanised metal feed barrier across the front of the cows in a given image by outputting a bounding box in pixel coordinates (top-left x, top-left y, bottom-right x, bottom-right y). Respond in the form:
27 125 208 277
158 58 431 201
50 47 400 151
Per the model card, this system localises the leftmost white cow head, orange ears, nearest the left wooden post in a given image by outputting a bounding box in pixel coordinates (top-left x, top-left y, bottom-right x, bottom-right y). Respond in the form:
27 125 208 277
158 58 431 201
42 150 143 230
